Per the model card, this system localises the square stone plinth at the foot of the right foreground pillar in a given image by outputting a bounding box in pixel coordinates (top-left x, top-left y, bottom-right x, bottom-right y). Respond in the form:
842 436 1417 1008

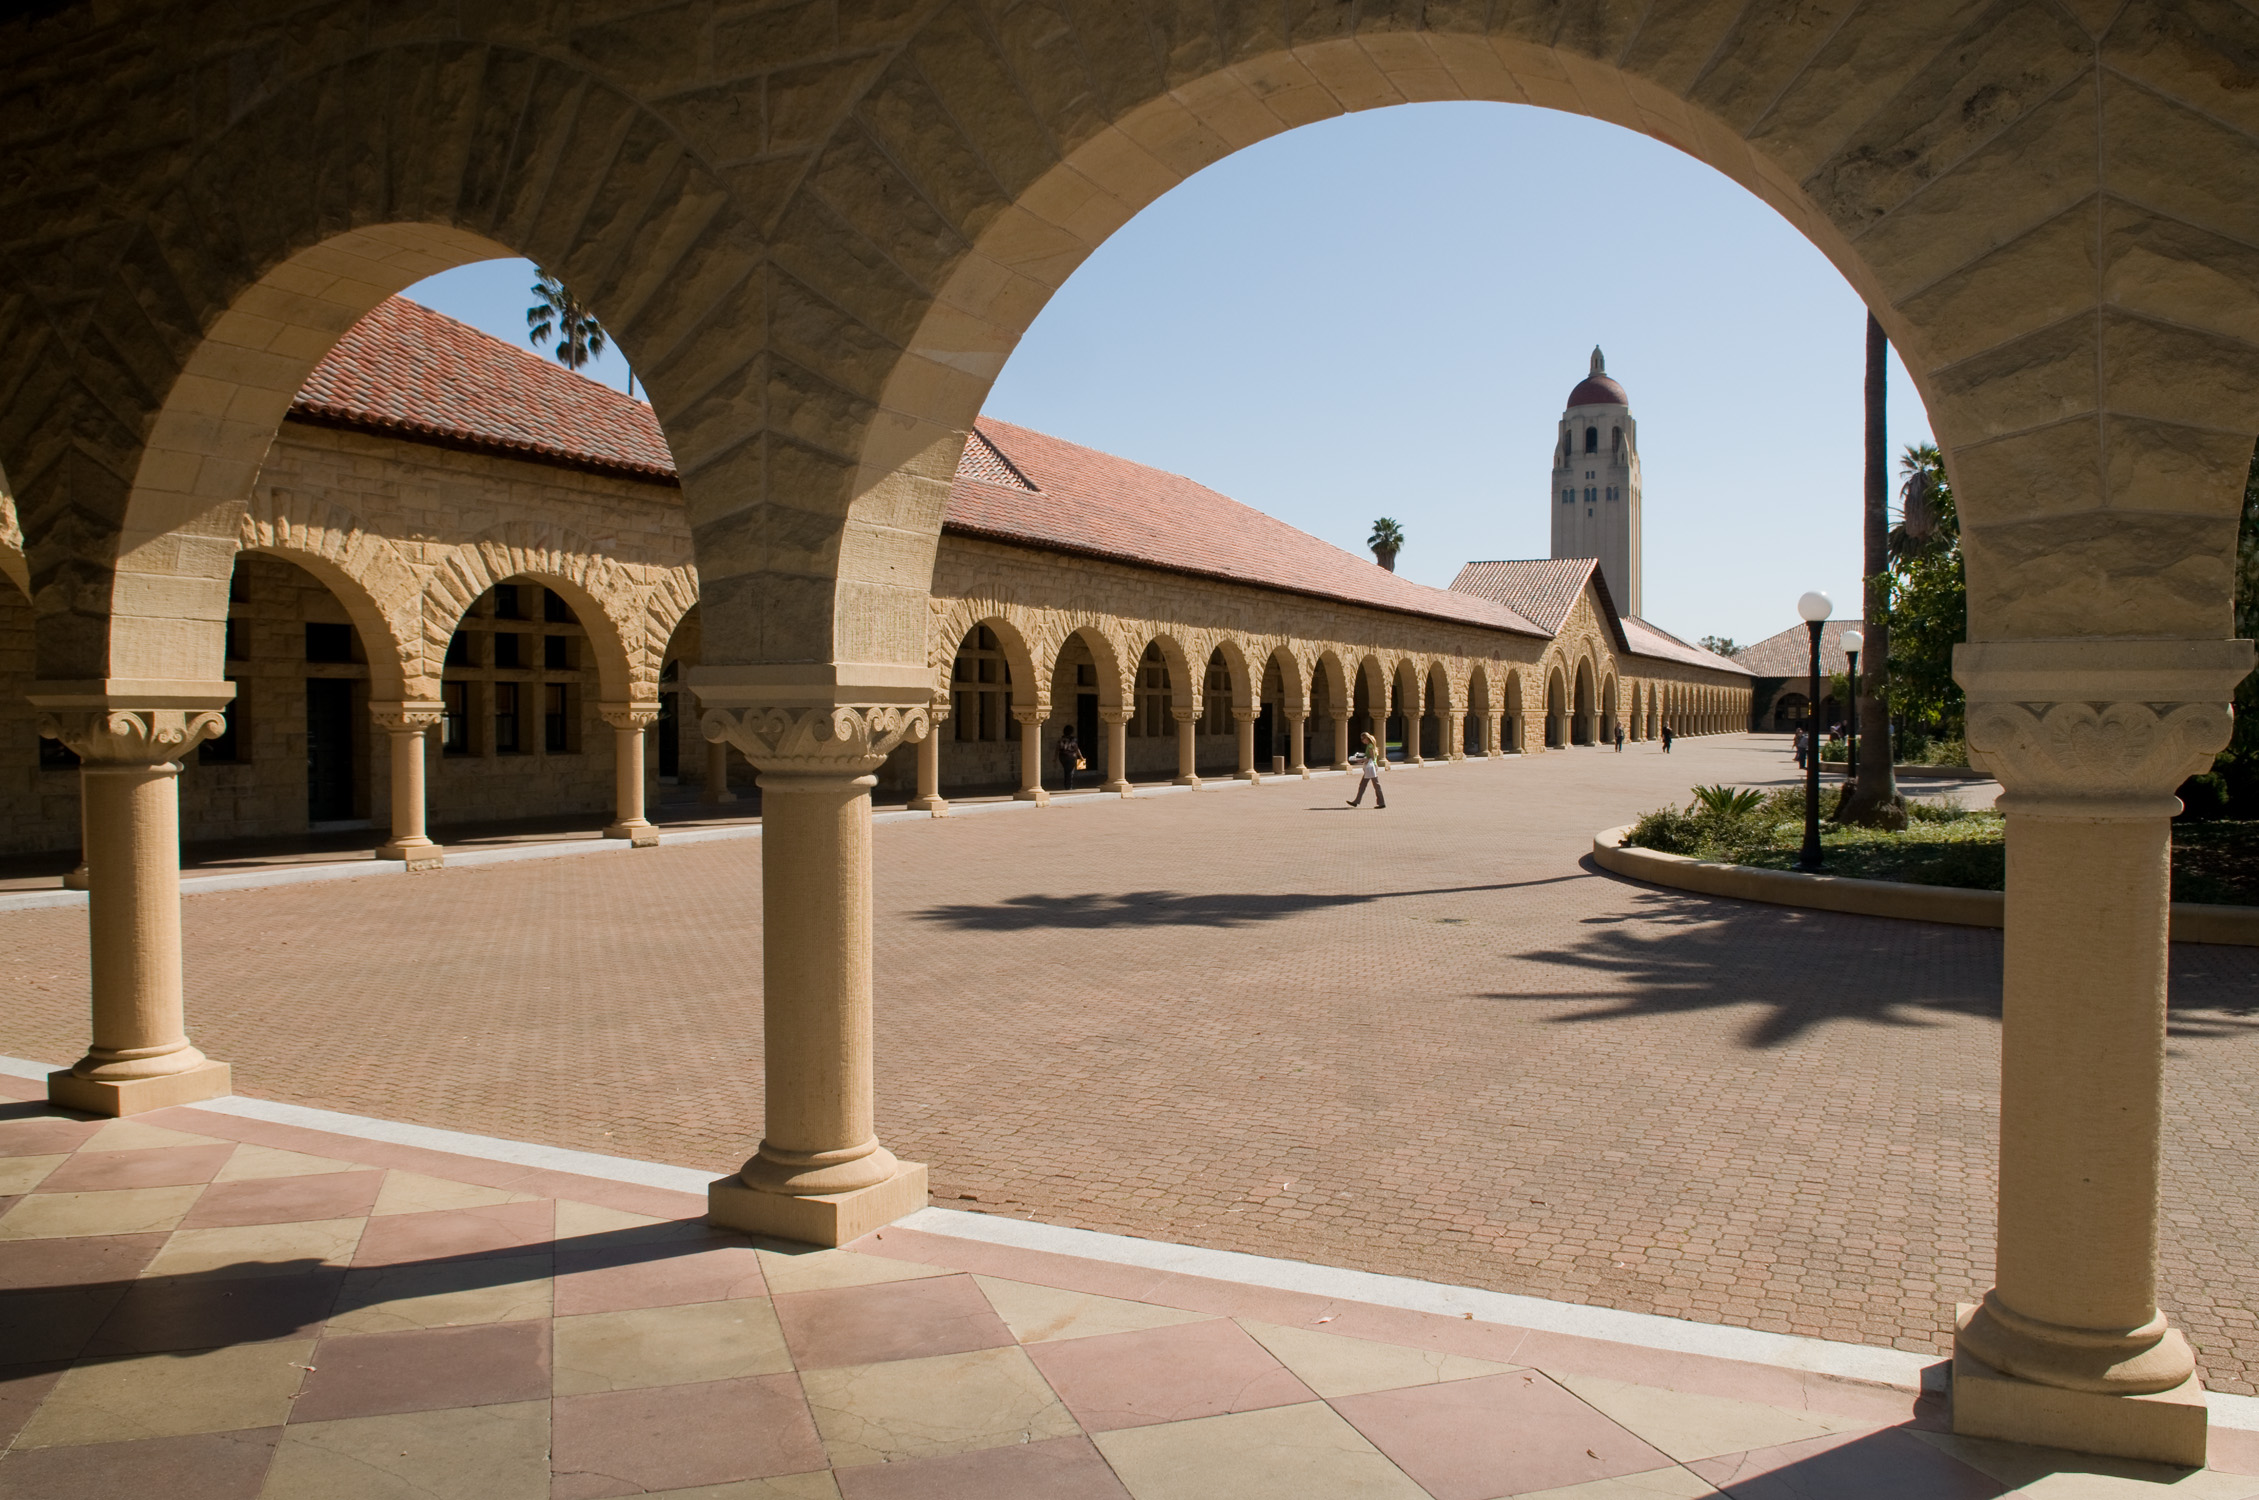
1952 1303 2209 1468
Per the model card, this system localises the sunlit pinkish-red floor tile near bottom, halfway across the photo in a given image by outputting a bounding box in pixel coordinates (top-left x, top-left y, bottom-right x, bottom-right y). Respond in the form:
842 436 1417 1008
1028 1319 1317 1432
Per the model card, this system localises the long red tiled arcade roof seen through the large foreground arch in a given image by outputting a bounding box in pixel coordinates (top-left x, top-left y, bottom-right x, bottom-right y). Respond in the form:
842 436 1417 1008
942 418 1552 635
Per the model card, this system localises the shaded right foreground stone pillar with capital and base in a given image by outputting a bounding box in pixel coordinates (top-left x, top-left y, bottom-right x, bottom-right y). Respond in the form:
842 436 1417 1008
1954 639 2252 1466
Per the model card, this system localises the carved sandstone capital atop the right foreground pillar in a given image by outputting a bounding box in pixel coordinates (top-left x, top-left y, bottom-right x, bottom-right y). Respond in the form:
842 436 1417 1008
1954 639 2252 818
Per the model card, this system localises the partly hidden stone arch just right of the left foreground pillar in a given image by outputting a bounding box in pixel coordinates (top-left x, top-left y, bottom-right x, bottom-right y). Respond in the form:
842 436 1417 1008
240 490 424 703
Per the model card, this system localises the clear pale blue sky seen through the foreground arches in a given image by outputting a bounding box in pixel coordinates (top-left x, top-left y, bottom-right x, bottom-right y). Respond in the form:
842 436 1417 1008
411 104 1929 642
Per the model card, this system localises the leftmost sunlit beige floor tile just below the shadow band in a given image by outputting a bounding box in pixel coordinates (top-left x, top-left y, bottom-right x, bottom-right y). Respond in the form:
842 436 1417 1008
16 1340 314 1448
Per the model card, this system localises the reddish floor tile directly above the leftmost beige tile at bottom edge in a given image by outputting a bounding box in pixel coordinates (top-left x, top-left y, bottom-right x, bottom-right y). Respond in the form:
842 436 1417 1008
291 1322 549 1421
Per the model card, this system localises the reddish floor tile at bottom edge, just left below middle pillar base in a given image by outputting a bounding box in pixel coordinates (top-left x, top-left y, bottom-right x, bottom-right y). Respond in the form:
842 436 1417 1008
549 1376 827 1500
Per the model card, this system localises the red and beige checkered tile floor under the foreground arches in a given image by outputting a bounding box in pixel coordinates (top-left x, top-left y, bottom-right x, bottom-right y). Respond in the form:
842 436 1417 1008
0 1080 2259 1500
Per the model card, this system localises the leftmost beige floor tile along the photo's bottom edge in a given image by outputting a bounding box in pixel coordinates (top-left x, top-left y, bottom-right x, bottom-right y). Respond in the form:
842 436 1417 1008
260 1401 549 1500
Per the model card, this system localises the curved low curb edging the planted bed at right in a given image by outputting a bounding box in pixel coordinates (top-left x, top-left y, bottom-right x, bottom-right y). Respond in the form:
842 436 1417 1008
1593 822 2259 947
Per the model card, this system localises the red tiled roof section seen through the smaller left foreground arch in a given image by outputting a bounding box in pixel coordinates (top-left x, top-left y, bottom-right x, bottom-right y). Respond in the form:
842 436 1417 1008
291 296 675 479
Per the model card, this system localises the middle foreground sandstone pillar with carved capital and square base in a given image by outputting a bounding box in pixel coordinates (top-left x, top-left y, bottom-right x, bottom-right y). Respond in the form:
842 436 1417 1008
700 695 931 1245
